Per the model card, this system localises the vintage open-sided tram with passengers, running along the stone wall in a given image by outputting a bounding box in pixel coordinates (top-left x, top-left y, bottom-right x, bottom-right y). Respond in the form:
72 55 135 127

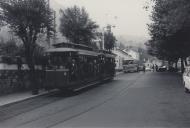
45 43 115 91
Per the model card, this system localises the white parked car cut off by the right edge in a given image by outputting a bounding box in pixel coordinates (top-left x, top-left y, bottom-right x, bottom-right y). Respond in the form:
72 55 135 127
183 67 190 93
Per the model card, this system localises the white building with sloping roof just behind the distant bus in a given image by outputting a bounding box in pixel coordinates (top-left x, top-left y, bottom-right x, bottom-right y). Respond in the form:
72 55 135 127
112 48 134 70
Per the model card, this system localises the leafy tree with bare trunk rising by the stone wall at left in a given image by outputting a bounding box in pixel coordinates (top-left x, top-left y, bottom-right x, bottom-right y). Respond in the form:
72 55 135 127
0 0 54 94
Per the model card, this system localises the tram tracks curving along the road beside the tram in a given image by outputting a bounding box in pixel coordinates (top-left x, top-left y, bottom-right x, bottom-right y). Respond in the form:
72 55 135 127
0 74 142 128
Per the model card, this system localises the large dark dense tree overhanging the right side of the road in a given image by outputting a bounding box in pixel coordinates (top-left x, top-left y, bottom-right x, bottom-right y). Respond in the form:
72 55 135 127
148 0 190 71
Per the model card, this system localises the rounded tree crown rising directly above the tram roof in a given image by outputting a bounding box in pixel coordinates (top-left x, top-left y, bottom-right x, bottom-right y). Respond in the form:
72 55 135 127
59 6 98 46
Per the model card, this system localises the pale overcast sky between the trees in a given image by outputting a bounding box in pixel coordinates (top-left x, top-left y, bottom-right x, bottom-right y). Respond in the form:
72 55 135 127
52 0 150 37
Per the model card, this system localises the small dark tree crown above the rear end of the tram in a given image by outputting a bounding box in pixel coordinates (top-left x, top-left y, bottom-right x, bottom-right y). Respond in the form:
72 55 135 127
104 31 116 51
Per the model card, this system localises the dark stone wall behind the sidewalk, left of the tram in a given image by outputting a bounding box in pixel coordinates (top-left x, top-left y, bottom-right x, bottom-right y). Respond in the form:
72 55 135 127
0 64 44 95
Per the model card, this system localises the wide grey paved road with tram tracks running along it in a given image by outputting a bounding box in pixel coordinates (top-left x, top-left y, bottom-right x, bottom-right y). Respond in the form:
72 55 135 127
0 72 190 128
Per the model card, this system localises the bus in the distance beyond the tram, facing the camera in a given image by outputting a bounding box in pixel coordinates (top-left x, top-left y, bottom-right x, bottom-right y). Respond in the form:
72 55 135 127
123 60 139 73
